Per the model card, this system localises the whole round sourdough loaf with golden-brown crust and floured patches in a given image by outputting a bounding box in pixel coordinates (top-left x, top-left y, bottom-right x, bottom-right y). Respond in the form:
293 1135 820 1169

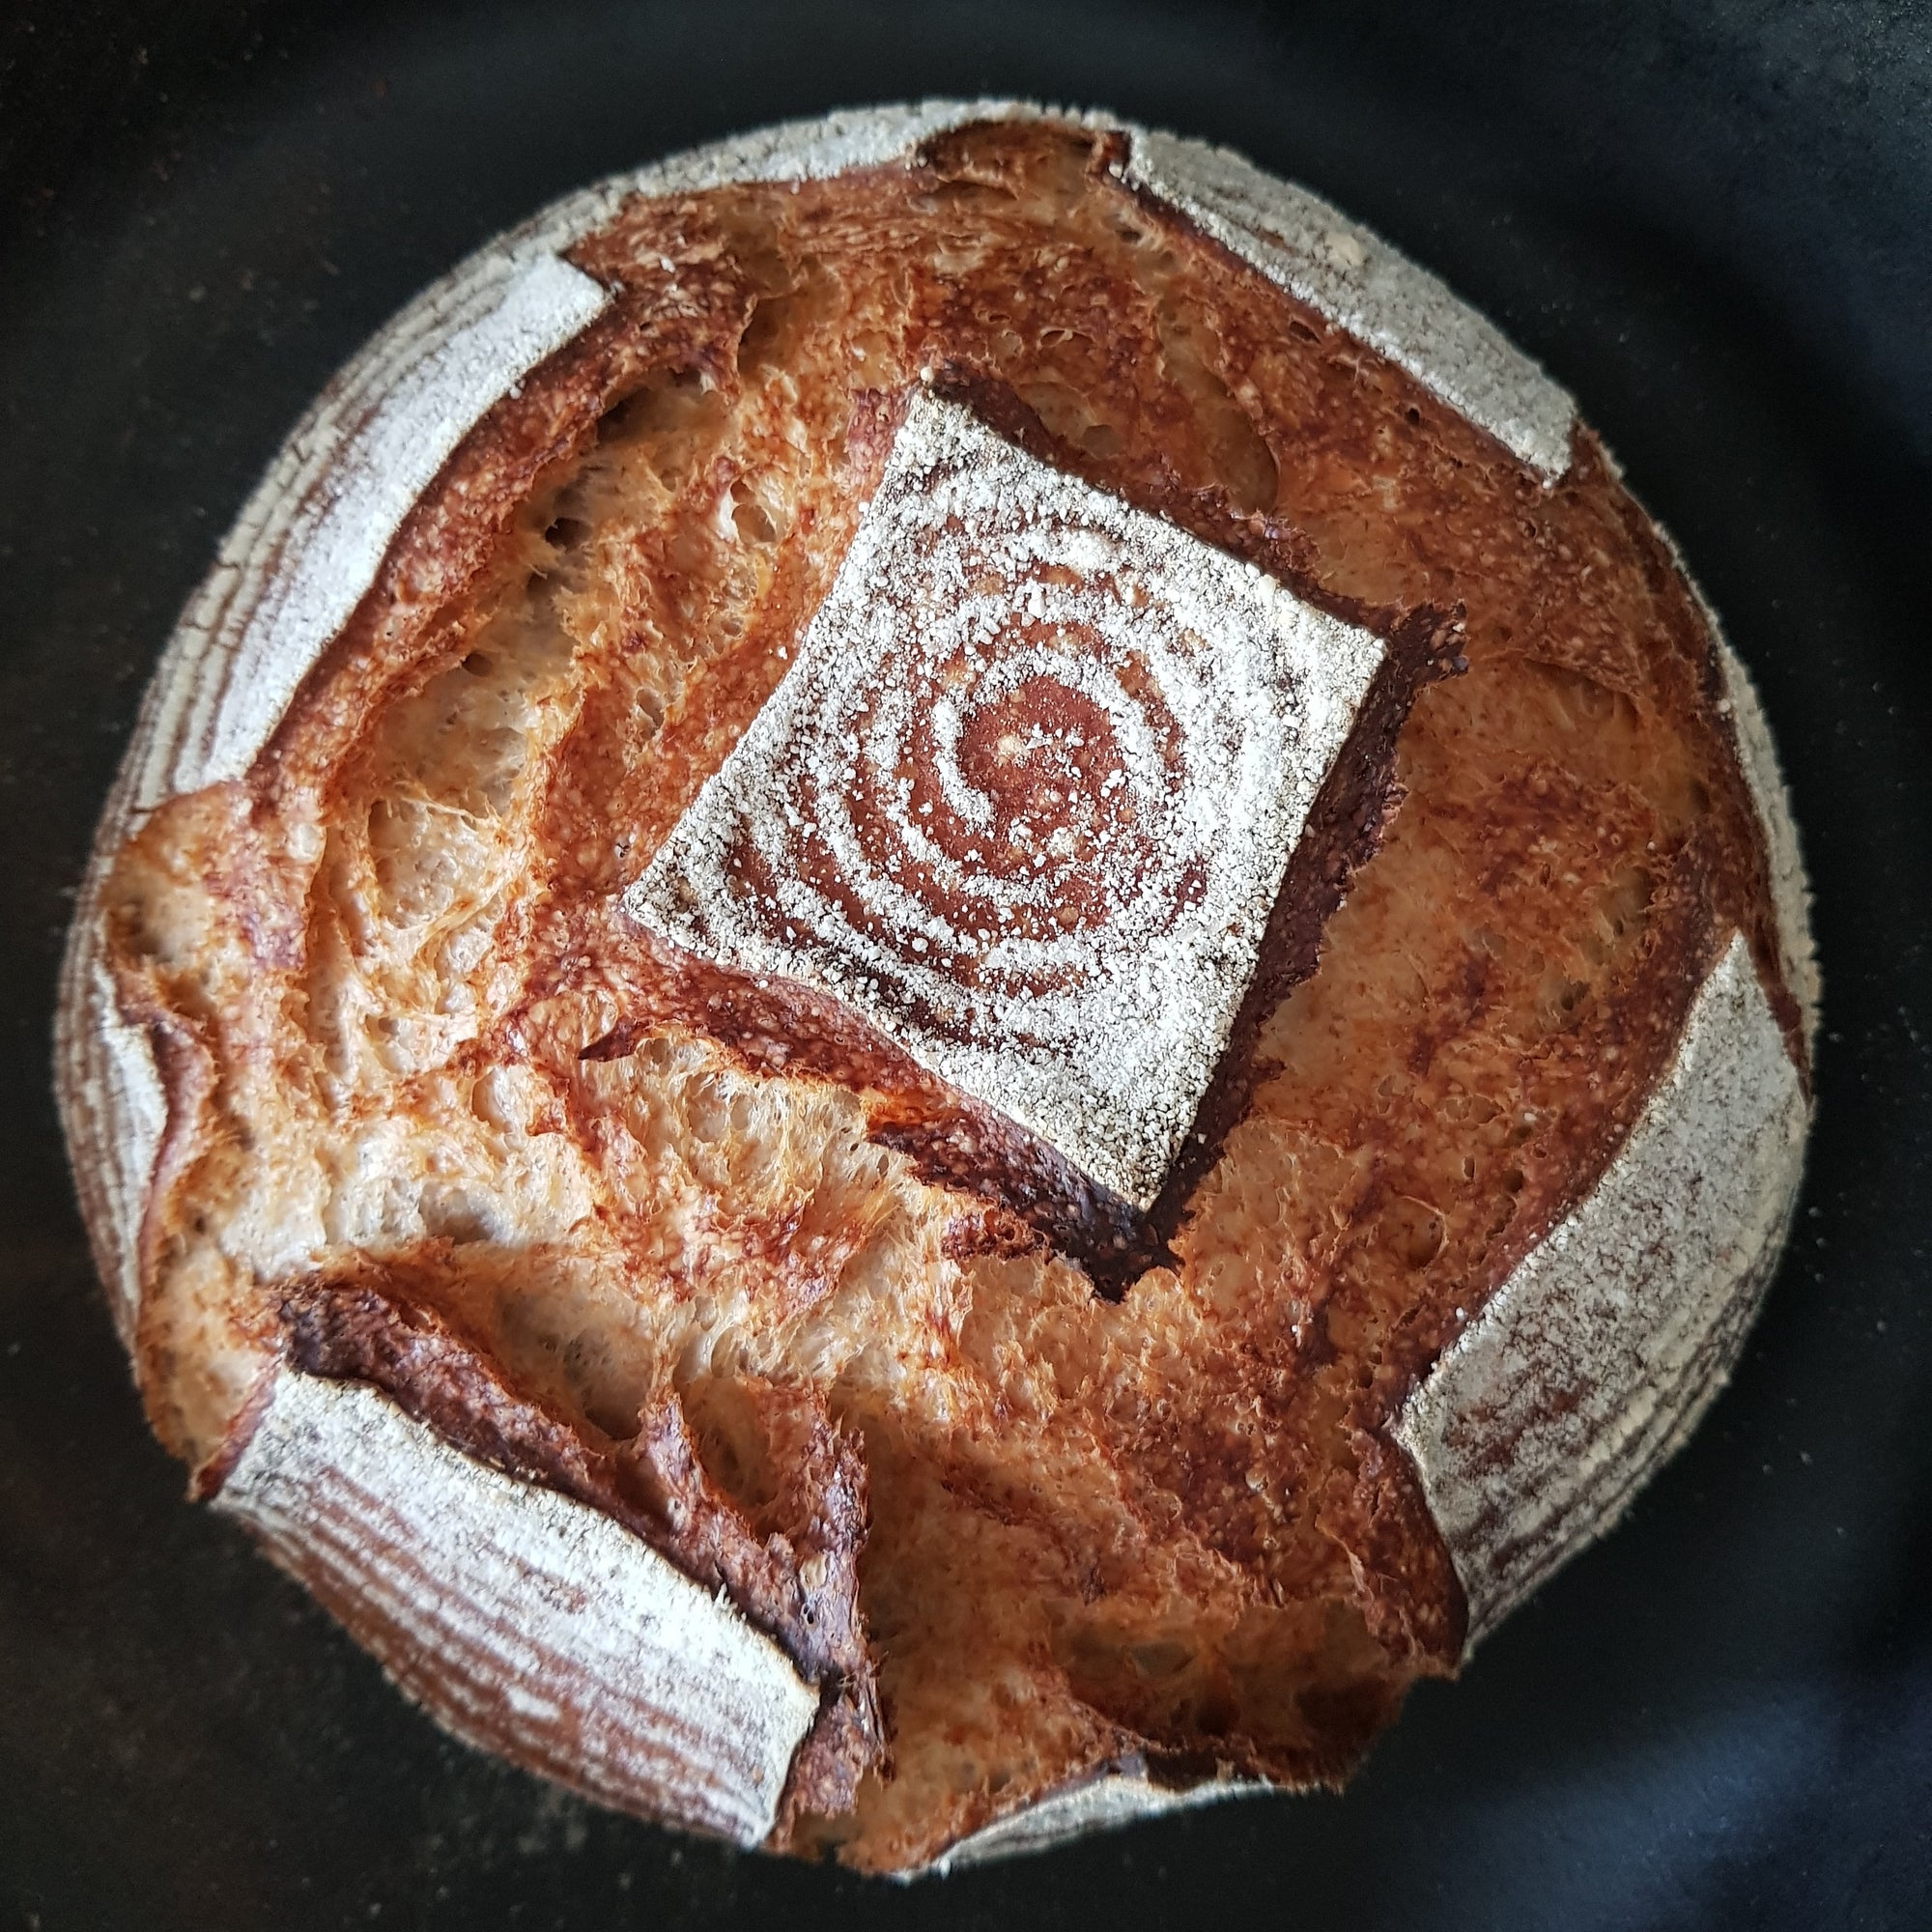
58 102 1816 1872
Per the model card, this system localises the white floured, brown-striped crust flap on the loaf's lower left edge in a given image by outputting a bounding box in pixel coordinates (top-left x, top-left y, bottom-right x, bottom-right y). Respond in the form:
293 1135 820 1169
214 1370 819 1845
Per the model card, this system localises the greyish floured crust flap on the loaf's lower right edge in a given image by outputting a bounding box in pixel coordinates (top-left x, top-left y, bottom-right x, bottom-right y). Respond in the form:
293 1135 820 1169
1393 937 1808 1644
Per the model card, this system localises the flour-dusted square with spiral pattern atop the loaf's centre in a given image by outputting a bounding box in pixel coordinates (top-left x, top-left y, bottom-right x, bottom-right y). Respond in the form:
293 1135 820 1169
624 390 1383 1209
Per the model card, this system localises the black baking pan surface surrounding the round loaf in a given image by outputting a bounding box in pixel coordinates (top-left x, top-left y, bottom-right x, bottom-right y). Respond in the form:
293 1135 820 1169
0 0 1932 1932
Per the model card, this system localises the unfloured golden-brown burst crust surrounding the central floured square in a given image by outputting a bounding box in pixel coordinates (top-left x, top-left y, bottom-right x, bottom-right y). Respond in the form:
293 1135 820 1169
83 113 1803 1868
